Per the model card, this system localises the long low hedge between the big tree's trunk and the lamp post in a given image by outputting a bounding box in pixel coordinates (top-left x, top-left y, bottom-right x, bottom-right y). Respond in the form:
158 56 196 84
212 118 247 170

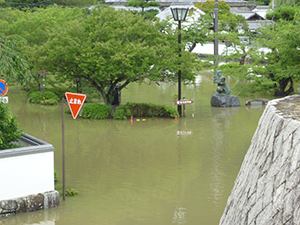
113 103 178 119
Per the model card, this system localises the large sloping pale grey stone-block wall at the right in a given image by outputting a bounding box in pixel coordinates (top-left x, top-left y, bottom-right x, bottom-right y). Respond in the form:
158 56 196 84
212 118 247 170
220 95 300 225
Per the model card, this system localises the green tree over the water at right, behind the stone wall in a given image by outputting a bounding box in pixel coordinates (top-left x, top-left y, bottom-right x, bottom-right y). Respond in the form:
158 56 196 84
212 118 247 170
221 18 300 96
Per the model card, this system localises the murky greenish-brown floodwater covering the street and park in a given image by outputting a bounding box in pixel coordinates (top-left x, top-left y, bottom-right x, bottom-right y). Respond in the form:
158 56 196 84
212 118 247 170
0 73 265 225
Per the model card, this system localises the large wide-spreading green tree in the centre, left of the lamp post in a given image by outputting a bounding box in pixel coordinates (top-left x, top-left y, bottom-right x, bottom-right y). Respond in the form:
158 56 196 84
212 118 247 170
27 6 199 105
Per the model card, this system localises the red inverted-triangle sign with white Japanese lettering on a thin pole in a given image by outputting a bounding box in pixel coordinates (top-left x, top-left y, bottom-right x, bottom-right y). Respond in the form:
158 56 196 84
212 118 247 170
62 92 86 200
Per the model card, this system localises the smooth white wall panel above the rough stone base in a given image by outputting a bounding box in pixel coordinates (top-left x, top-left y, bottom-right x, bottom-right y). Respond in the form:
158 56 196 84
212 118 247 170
0 151 54 200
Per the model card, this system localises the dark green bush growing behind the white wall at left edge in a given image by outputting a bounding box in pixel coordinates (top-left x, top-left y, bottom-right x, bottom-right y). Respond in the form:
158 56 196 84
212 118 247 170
0 102 24 150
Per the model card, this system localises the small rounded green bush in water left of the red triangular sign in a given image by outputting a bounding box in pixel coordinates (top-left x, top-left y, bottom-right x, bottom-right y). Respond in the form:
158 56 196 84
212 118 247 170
29 90 60 105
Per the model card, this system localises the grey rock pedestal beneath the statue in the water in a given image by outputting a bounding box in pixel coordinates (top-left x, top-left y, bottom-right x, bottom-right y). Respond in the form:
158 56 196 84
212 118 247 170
210 94 240 107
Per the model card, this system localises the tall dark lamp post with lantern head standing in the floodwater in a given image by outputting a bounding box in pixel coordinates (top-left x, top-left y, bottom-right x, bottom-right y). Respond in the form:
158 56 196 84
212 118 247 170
170 3 190 117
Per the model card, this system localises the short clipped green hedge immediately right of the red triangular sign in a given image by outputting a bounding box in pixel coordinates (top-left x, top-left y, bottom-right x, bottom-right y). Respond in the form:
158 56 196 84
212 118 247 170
79 103 110 119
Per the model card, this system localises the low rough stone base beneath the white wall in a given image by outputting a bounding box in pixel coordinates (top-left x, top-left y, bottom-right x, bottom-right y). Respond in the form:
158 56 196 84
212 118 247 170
0 191 59 217
